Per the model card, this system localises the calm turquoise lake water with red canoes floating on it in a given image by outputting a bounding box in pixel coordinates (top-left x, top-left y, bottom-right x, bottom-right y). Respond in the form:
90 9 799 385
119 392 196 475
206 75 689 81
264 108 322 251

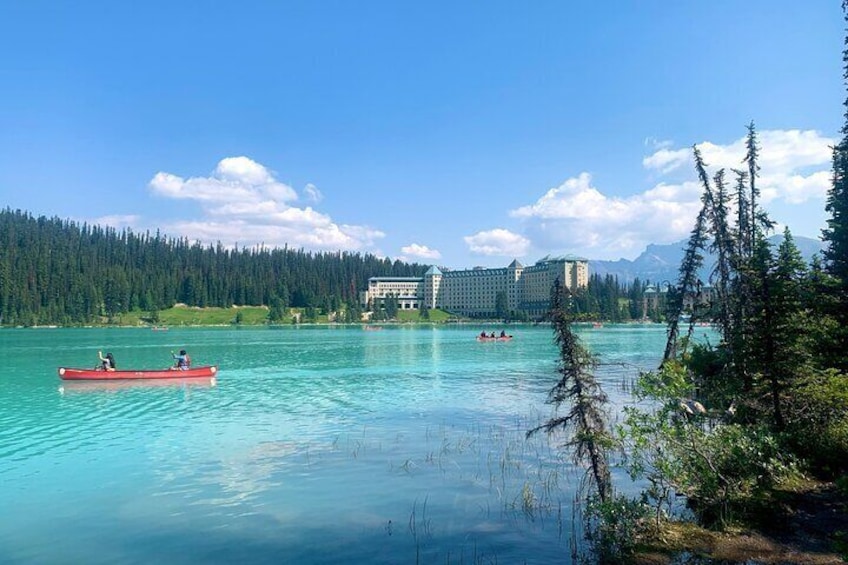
0 325 684 564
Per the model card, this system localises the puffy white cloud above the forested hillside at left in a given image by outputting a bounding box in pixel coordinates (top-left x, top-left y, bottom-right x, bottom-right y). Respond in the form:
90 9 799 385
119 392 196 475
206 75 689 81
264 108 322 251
149 157 385 251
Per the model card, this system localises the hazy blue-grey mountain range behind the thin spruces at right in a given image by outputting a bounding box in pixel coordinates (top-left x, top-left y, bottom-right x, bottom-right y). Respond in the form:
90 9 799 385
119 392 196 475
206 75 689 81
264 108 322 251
589 235 824 283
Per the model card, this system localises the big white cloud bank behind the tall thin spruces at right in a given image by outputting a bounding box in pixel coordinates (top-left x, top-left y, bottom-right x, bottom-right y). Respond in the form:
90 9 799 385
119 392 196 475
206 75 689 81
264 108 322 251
510 130 835 259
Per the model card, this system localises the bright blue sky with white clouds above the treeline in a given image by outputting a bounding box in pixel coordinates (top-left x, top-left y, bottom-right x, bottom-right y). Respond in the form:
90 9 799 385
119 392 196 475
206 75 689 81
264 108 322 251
0 0 845 268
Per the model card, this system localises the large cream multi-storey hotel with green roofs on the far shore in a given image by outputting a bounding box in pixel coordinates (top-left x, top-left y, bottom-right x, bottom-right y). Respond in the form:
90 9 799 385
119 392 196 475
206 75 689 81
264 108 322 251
360 256 589 317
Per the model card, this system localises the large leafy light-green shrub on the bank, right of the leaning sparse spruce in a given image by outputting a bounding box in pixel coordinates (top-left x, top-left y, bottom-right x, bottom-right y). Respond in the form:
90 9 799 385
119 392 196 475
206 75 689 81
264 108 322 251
619 374 798 526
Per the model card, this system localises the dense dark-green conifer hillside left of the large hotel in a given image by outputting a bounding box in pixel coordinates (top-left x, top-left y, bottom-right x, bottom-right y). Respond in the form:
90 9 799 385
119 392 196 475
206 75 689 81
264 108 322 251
0 209 426 326
